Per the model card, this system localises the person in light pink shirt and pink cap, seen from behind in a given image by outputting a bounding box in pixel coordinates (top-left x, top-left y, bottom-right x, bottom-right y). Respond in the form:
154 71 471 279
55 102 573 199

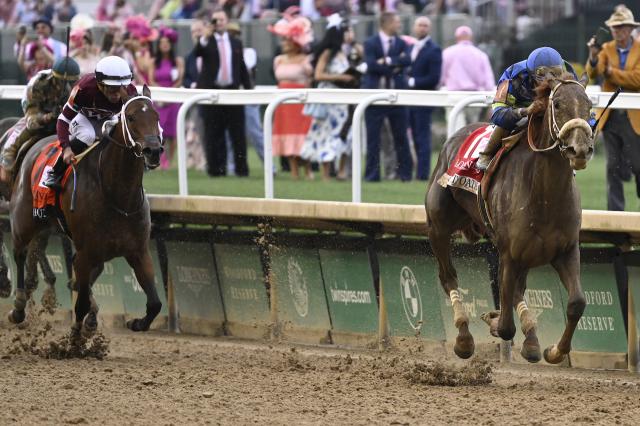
440 25 496 128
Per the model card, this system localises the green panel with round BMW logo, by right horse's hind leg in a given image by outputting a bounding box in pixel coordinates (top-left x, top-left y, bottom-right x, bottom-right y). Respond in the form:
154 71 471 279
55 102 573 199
378 253 442 341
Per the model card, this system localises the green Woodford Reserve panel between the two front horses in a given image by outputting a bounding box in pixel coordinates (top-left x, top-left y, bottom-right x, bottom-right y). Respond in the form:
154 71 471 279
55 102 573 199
214 244 270 325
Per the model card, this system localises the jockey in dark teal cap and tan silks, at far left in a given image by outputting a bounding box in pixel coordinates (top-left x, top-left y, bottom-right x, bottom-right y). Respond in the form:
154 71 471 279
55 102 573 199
0 57 80 182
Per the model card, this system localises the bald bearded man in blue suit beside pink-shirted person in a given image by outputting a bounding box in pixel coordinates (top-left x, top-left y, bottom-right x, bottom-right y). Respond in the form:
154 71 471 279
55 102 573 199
408 16 442 180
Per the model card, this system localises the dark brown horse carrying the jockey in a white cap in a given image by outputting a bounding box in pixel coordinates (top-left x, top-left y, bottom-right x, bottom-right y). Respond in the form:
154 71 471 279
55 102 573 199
9 86 163 336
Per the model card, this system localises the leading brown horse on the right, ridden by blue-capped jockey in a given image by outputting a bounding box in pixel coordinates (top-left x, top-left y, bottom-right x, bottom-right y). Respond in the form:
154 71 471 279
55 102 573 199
425 75 594 364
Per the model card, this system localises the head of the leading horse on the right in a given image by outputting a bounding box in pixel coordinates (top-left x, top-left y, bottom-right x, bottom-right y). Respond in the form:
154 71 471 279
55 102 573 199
536 74 594 170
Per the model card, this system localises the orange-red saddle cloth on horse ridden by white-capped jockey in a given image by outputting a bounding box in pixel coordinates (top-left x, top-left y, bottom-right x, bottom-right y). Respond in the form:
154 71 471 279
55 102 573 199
31 141 71 219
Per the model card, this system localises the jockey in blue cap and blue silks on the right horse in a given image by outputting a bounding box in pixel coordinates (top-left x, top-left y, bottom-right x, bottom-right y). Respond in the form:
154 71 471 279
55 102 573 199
476 47 575 170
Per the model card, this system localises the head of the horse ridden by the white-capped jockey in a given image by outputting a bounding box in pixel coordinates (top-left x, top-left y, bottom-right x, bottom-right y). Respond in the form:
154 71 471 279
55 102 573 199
120 84 164 169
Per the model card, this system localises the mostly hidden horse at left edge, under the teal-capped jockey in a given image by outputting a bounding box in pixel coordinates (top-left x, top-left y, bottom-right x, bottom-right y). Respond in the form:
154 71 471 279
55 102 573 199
0 117 56 302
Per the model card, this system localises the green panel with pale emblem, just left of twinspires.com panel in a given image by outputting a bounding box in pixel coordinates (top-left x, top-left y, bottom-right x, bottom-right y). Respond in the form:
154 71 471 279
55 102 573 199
270 247 331 331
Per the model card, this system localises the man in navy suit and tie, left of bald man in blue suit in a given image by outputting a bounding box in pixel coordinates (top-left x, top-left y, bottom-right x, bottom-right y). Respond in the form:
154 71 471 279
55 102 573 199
362 12 412 182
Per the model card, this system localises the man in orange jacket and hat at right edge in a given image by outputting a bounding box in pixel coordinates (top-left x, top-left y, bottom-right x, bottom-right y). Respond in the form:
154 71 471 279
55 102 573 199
586 6 640 211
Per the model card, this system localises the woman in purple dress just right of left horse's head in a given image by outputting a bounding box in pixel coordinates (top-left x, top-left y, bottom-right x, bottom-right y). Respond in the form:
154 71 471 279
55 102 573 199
149 28 184 170
